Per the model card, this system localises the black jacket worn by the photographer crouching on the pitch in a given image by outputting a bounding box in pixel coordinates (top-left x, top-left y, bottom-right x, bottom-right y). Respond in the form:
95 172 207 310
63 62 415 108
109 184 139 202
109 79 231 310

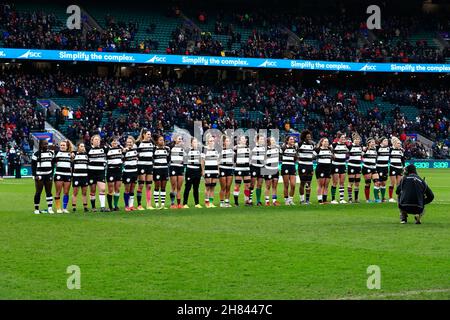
397 174 434 209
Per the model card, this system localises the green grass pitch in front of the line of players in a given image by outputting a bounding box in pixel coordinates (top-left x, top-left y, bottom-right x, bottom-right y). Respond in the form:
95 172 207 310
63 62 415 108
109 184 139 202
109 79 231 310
0 169 450 299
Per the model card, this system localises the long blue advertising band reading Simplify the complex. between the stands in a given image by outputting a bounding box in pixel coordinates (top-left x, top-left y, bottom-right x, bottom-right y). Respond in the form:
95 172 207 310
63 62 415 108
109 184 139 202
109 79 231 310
0 48 450 73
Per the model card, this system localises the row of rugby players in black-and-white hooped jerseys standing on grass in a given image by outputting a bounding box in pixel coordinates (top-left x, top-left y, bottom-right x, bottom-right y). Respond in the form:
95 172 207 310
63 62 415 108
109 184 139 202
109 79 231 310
32 129 405 214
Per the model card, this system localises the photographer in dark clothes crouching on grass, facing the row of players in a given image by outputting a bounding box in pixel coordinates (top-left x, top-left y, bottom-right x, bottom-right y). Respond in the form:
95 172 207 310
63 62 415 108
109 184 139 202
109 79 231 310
396 164 434 224
